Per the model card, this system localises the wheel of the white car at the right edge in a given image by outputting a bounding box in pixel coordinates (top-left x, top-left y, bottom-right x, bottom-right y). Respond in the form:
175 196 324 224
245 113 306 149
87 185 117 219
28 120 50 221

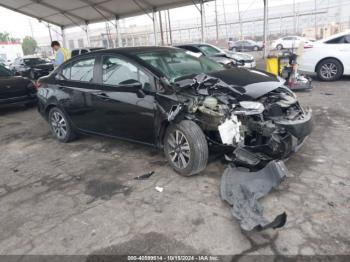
316 58 344 81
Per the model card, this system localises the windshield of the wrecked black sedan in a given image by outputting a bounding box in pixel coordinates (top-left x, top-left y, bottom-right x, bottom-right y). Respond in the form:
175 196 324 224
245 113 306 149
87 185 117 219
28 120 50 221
135 49 224 82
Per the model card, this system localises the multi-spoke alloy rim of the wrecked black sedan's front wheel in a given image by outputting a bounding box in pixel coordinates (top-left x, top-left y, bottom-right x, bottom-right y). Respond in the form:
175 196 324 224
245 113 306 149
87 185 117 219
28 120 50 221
167 130 191 168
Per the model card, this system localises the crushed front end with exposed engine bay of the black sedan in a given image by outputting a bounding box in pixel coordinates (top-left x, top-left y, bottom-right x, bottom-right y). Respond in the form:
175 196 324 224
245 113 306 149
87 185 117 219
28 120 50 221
170 74 312 170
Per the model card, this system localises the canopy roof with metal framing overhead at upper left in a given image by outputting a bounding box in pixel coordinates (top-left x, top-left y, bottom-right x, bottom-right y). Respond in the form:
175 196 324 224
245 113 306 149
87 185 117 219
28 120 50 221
0 0 208 28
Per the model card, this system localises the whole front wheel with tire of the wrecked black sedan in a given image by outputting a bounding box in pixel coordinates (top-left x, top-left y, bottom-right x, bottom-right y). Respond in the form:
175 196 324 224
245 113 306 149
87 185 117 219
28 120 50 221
164 120 209 176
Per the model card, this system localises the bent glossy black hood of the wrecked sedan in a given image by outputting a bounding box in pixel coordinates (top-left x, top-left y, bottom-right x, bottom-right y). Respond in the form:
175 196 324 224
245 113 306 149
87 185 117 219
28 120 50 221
208 68 283 99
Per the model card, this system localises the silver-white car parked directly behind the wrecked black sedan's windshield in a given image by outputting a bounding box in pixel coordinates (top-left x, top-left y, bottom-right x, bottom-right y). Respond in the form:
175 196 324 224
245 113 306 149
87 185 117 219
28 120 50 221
177 44 256 68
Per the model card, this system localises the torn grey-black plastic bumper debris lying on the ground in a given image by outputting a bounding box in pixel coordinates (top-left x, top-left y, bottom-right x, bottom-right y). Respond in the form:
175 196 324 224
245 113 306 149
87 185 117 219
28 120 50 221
220 161 288 231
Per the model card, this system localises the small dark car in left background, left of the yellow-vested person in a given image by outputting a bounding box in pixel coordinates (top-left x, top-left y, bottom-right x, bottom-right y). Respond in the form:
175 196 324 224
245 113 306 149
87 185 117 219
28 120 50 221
10 57 54 79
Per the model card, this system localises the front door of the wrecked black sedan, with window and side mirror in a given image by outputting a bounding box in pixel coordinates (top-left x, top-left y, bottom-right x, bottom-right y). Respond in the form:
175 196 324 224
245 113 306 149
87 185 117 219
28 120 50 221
92 55 155 144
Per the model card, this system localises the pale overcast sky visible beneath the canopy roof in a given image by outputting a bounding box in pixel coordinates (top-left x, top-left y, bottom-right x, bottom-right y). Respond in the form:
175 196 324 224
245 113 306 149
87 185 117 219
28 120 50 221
0 0 314 41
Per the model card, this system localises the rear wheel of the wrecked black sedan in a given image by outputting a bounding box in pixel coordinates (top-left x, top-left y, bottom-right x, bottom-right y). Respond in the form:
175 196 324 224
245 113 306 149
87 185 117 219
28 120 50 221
49 107 76 143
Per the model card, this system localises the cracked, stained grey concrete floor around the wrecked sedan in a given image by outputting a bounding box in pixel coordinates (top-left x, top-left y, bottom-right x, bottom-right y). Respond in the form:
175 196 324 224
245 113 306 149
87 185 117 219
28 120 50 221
0 79 350 255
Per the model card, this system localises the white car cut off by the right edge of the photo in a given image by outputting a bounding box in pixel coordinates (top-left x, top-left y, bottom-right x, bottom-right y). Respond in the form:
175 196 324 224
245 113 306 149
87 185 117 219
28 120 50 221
299 30 350 81
